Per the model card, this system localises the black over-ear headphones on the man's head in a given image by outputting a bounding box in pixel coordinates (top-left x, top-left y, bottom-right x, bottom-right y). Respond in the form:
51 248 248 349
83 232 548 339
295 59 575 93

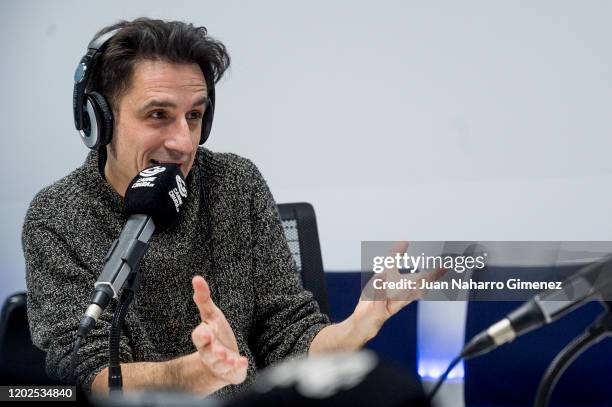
72 28 215 150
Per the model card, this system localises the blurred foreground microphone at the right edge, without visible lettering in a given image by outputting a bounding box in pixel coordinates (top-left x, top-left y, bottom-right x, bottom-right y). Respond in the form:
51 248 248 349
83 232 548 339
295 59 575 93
461 254 612 359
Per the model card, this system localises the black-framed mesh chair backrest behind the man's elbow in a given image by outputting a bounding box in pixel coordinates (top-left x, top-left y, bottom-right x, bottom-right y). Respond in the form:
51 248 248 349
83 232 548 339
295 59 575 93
278 202 329 315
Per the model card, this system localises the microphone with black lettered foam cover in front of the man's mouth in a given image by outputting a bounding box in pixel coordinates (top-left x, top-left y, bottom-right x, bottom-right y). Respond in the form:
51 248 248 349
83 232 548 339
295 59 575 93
77 164 187 338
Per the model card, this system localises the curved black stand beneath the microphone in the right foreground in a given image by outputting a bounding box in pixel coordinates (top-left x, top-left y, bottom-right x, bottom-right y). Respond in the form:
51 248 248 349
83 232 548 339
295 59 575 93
533 301 612 407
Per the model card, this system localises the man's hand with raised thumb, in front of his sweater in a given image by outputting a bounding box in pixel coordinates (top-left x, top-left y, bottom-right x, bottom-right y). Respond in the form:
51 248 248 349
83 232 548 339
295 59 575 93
191 276 249 389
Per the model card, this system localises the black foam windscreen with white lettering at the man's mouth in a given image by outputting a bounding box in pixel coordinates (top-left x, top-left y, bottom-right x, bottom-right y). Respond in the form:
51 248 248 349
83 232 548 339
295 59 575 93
124 164 187 232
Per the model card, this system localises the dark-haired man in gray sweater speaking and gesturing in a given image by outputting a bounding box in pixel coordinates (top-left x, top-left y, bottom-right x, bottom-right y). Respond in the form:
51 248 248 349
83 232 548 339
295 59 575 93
23 19 438 394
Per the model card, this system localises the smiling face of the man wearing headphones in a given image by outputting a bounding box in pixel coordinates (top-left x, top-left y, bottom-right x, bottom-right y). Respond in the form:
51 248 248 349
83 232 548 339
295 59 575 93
104 60 207 196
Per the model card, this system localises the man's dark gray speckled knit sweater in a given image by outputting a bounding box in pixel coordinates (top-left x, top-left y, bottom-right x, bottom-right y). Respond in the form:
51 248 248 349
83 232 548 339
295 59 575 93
23 148 329 395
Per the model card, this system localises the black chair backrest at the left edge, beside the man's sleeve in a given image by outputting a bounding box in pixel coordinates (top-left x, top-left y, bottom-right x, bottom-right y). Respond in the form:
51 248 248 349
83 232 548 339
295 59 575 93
0 292 57 385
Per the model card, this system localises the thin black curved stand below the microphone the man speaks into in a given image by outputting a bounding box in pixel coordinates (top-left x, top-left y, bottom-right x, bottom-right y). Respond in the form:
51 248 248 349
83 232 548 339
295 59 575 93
108 265 140 393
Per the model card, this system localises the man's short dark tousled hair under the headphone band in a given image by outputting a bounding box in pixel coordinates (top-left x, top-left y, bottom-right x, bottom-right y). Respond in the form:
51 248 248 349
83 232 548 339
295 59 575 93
89 18 230 113
